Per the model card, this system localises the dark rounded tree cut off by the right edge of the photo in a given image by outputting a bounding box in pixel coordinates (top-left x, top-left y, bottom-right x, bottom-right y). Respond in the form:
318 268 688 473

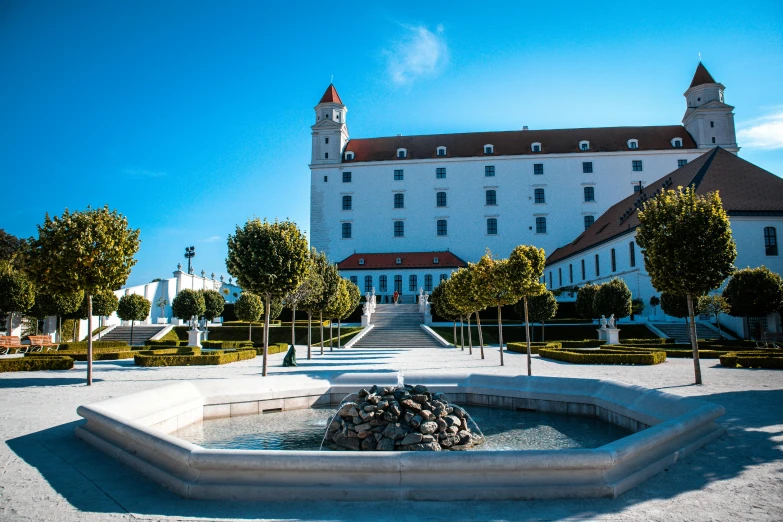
723 266 783 338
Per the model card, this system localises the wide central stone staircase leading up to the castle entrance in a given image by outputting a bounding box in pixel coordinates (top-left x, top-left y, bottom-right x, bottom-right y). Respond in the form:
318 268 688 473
353 304 441 349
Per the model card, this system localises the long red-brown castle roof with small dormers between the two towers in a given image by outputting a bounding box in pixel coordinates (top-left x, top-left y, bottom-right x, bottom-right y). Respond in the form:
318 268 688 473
345 125 696 163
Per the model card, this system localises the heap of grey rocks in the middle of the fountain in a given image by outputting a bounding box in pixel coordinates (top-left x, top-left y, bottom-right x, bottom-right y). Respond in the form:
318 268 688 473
325 384 484 451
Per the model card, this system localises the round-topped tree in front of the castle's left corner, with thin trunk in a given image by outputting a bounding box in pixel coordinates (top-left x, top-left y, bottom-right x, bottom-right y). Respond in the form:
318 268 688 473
226 218 309 376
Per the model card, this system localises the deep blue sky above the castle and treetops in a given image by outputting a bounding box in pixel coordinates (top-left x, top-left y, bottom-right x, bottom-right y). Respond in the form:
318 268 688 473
0 0 783 284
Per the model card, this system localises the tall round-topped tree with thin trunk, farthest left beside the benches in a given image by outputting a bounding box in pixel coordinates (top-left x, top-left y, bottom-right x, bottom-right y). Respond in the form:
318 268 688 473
29 206 139 385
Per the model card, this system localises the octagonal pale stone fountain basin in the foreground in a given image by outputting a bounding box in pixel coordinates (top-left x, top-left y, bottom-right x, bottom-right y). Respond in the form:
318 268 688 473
76 371 725 501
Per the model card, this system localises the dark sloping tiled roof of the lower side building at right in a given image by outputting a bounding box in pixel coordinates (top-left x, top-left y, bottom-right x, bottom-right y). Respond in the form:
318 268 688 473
547 147 783 265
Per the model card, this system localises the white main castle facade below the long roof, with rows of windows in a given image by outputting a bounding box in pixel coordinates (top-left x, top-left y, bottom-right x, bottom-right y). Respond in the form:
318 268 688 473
310 149 703 261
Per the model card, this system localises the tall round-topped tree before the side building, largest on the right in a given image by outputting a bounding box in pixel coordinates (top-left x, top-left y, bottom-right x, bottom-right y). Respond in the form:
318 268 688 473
636 187 737 384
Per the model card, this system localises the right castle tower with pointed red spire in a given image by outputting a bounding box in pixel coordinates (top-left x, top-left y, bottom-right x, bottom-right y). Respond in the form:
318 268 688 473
682 62 739 154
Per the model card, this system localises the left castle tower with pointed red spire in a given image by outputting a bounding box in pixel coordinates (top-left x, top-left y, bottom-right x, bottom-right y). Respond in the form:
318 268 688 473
311 84 349 165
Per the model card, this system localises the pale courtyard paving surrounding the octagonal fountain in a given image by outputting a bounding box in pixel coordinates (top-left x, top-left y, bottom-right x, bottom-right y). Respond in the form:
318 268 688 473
0 347 783 522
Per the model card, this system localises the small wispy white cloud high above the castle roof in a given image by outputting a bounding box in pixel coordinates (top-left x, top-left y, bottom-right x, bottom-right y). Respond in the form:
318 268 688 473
385 25 449 85
